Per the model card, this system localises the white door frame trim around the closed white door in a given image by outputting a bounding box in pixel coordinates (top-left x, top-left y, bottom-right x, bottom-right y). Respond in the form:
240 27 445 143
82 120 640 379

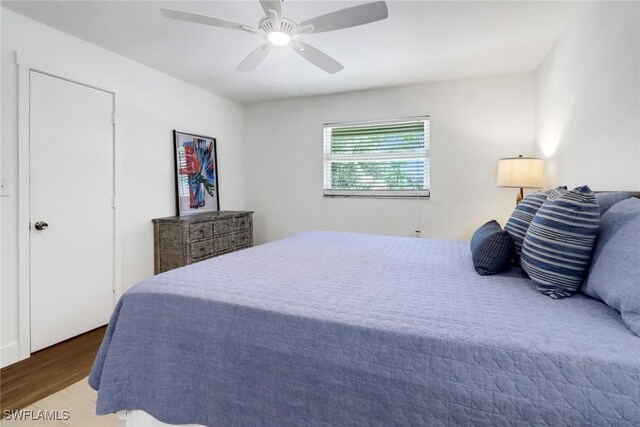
16 52 122 360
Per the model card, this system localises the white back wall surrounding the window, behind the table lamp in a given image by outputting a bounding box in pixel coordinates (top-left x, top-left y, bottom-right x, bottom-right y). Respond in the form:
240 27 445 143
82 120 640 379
245 73 535 243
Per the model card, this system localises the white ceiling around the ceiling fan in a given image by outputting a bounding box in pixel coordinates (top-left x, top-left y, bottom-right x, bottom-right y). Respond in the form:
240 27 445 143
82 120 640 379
2 0 578 103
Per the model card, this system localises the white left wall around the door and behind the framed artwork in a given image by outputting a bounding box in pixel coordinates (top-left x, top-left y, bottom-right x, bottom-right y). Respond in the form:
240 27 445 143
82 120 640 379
1 10 245 365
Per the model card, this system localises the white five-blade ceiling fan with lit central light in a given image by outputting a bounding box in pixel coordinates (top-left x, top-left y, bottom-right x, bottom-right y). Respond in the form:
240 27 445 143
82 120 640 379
160 0 389 74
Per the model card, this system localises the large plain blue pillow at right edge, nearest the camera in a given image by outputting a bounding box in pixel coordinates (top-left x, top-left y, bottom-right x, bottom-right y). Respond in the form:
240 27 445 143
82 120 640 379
582 198 640 336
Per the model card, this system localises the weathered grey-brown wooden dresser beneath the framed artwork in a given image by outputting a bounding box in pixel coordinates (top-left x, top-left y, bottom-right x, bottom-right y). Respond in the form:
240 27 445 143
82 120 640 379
153 211 253 274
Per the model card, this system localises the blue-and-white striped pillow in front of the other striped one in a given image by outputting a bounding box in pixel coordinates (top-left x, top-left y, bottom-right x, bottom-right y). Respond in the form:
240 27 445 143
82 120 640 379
520 185 600 299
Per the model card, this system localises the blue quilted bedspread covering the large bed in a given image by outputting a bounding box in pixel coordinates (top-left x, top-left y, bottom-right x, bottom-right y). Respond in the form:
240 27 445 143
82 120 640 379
89 232 640 426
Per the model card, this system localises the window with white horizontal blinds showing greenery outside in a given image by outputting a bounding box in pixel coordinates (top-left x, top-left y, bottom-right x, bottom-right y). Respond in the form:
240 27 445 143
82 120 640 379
324 116 429 197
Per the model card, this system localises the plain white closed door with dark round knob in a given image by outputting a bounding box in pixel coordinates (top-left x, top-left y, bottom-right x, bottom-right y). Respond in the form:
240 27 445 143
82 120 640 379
29 71 114 352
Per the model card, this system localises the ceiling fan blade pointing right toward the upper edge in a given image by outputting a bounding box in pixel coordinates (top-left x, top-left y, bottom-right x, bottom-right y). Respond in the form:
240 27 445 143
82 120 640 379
300 1 389 33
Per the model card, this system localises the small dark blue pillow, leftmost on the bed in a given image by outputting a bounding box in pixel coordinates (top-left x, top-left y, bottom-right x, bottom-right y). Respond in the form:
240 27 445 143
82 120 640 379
471 220 514 276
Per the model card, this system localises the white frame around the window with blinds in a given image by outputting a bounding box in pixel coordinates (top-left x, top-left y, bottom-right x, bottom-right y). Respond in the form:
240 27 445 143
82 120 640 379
322 115 431 199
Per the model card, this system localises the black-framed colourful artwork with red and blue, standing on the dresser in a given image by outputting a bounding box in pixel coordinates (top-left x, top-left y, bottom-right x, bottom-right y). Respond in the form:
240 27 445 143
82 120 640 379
173 130 220 216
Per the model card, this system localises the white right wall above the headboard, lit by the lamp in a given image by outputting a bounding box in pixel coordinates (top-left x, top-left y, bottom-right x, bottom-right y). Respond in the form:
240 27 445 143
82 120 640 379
536 2 640 191
